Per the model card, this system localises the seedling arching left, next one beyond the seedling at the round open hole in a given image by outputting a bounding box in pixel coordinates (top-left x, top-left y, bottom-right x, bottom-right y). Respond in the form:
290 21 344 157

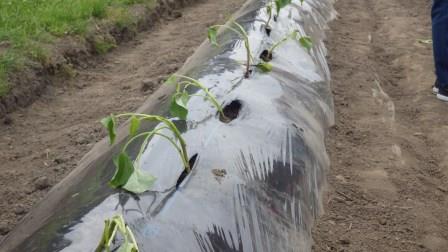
208 21 272 78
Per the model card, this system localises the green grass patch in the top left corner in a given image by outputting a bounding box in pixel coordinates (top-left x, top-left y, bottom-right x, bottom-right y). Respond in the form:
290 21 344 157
0 0 156 96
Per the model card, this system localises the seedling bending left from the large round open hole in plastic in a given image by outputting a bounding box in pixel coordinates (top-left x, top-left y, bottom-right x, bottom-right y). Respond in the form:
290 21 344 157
166 74 229 121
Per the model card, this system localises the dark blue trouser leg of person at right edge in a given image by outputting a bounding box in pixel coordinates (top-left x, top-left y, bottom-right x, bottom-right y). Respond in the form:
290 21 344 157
432 0 448 90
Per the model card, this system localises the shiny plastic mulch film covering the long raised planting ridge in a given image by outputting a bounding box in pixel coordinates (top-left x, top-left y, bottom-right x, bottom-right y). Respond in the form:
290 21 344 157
0 0 335 252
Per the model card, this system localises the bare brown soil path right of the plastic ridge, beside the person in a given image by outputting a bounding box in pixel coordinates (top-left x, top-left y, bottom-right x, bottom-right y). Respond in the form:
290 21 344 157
313 0 448 252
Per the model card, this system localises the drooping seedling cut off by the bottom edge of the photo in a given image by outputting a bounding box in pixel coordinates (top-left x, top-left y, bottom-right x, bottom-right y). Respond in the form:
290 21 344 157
95 215 139 252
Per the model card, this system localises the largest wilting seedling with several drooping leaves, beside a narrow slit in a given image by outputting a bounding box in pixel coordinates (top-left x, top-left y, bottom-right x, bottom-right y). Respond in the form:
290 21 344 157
101 113 191 194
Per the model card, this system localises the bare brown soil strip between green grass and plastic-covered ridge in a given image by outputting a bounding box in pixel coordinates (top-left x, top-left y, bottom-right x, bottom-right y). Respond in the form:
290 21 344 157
0 0 245 240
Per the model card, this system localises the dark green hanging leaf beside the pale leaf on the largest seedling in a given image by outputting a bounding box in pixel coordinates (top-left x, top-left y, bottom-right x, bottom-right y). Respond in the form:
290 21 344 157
109 152 135 188
